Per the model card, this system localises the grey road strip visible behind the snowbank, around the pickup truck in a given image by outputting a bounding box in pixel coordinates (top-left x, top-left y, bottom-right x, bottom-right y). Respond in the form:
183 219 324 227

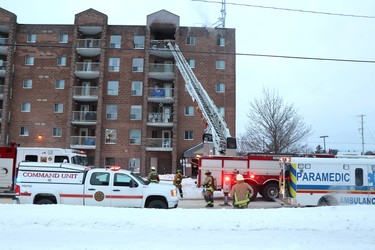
0 197 282 209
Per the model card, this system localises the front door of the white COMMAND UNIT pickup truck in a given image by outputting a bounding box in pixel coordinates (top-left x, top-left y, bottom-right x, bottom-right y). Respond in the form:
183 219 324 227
111 173 143 207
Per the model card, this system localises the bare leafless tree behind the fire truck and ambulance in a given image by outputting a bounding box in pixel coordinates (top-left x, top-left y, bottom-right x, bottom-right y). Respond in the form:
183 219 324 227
244 88 311 153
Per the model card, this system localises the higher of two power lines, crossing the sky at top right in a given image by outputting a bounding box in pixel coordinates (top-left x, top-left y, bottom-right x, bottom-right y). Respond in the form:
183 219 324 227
191 0 375 19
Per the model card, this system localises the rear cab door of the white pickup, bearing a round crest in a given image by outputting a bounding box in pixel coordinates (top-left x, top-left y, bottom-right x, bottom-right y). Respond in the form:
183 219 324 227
84 171 112 207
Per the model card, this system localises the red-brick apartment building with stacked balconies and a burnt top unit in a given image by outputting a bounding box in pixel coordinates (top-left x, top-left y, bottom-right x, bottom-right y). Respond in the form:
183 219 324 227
0 8 236 176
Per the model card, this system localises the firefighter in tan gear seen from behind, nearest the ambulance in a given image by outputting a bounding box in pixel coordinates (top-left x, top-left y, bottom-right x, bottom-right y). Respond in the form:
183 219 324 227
230 174 252 208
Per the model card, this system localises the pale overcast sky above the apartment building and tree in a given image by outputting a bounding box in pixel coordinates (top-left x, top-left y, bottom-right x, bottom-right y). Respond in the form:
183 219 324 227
0 0 375 152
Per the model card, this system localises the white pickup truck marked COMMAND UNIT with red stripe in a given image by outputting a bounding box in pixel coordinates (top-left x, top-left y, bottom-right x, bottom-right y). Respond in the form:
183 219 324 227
16 162 179 208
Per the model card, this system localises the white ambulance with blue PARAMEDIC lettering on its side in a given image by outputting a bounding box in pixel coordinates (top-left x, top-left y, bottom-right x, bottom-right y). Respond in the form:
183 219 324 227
279 157 375 206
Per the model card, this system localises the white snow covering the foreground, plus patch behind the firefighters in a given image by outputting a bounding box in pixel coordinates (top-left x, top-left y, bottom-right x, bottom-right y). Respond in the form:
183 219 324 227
0 179 375 250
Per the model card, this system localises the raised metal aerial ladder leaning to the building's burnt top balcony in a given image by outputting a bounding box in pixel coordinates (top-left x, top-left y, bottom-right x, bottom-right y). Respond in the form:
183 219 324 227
168 42 237 155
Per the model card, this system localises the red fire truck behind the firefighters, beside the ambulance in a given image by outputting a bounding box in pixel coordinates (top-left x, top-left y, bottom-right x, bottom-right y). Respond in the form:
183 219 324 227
198 155 281 201
